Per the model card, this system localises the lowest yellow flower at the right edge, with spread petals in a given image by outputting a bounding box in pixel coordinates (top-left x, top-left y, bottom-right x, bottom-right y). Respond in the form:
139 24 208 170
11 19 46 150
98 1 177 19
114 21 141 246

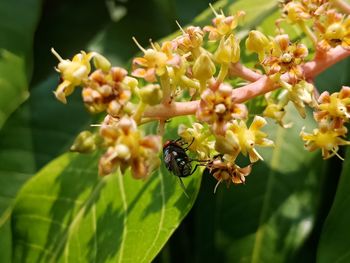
300 120 350 159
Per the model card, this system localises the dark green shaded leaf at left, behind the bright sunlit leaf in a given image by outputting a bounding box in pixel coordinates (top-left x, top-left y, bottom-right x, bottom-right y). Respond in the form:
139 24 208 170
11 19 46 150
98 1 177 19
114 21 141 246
0 78 87 262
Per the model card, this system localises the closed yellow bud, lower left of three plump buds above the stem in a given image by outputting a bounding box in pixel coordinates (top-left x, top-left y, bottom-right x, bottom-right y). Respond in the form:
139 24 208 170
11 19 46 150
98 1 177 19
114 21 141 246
193 53 216 81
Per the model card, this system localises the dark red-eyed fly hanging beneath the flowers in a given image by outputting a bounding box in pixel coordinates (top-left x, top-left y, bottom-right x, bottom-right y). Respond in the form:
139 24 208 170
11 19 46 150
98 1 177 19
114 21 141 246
163 138 200 198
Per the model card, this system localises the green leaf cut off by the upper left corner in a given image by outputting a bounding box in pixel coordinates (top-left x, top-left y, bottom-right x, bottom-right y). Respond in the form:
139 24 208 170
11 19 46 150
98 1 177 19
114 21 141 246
0 0 41 128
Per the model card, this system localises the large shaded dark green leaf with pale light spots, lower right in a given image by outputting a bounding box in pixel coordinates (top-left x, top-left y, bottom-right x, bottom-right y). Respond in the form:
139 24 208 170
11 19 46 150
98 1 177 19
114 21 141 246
195 105 324 262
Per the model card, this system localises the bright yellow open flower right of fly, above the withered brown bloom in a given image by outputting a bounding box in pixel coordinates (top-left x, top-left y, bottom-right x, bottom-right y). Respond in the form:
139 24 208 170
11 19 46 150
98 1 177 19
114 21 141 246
215 116 274 163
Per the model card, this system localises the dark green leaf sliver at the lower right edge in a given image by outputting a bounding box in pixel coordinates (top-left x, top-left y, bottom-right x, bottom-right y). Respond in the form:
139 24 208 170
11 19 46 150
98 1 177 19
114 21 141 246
317 148 350 263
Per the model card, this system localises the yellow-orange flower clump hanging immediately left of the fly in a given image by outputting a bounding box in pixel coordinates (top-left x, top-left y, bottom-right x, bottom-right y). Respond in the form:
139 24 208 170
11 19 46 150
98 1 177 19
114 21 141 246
99 116 161 179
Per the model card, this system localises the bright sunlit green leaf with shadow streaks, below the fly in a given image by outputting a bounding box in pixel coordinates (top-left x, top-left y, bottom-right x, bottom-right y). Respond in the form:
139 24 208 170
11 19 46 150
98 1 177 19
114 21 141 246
13 147 201 262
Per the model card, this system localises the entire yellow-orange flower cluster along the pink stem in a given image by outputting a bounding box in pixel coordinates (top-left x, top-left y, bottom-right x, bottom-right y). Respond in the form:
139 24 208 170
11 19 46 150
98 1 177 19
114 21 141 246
52 0 350 194
